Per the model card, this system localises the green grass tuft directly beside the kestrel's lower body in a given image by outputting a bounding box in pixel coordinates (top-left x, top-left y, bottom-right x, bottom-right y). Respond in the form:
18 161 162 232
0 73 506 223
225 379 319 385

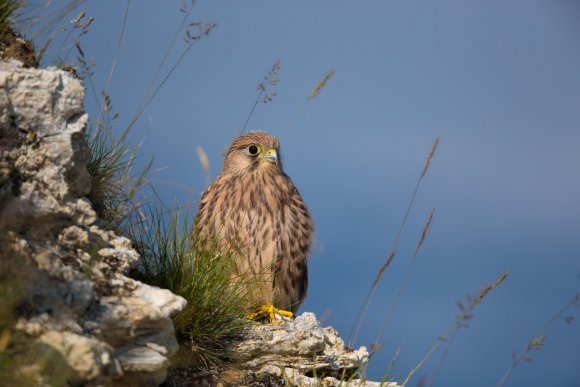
129 206 254 369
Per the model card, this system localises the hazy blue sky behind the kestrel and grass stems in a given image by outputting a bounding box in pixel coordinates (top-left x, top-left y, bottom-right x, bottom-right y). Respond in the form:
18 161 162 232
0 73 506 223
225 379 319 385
32 0 580 386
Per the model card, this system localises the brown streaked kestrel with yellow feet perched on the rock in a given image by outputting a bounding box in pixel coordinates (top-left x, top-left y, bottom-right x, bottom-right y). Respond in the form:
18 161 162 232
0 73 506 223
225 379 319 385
195 132 313 319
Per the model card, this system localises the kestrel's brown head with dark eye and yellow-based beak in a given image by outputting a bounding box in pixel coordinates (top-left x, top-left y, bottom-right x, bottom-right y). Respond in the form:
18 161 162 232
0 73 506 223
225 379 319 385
224 132 282 174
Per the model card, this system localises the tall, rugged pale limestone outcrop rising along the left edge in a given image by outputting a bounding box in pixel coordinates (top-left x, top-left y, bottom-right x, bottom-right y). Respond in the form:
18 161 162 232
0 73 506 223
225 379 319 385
0 62 185 386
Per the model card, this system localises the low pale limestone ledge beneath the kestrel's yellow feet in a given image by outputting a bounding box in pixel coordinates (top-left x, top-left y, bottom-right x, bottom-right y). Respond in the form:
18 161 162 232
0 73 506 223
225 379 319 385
235 312 396 387
